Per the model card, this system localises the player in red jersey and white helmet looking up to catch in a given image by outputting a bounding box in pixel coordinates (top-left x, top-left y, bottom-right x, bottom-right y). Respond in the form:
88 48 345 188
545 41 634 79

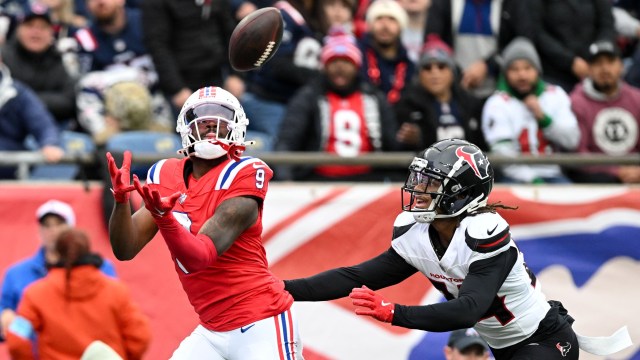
107 87 302 360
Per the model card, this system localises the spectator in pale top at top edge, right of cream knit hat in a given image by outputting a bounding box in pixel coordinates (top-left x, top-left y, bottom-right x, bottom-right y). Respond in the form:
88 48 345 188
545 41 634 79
398 0 431 64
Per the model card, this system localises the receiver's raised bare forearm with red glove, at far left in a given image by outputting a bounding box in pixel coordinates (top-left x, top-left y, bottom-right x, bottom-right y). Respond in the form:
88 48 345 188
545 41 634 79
107 151 158 260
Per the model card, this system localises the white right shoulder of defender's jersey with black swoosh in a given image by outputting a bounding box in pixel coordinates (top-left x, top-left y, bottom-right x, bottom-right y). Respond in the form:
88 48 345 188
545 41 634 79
465 213 511 253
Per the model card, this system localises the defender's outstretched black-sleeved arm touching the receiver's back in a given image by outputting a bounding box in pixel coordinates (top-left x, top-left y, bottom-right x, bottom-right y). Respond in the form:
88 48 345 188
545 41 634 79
284 248 418 301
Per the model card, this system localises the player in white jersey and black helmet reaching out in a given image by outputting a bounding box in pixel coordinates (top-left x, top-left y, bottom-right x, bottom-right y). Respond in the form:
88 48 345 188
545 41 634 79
285 139 632 360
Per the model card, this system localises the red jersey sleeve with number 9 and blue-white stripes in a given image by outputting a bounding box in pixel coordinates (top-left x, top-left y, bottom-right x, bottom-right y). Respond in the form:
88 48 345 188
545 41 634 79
215 157 273 201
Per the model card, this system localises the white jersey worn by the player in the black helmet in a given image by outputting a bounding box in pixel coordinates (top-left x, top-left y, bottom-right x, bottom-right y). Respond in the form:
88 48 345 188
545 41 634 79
392 213 550 349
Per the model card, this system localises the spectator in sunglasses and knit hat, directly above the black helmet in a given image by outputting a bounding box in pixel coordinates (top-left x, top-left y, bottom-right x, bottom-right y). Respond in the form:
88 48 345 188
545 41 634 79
395 35 487 151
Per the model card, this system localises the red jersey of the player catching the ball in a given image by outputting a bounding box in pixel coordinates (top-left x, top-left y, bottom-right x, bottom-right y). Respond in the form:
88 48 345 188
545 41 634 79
147 157 293 331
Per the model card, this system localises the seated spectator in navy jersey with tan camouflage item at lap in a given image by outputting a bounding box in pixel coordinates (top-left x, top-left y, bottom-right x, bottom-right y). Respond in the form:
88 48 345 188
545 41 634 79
76 0 173 145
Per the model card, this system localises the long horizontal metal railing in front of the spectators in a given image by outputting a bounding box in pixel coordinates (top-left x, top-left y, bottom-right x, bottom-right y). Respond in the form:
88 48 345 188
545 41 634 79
0 151 640 180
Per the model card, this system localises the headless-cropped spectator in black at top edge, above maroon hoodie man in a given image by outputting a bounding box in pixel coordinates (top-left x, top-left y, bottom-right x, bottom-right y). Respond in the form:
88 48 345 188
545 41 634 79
529 0 615 92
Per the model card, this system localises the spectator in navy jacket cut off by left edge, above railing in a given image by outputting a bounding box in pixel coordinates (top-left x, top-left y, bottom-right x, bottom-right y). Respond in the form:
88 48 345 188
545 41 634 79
0 53 64 179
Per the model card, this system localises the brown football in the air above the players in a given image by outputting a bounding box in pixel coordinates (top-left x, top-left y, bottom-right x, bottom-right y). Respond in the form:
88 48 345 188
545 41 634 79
229 7 284 71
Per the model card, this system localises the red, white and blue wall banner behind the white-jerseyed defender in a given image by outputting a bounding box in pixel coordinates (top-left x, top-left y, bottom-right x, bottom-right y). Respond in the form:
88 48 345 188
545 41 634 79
264 185 640 360
